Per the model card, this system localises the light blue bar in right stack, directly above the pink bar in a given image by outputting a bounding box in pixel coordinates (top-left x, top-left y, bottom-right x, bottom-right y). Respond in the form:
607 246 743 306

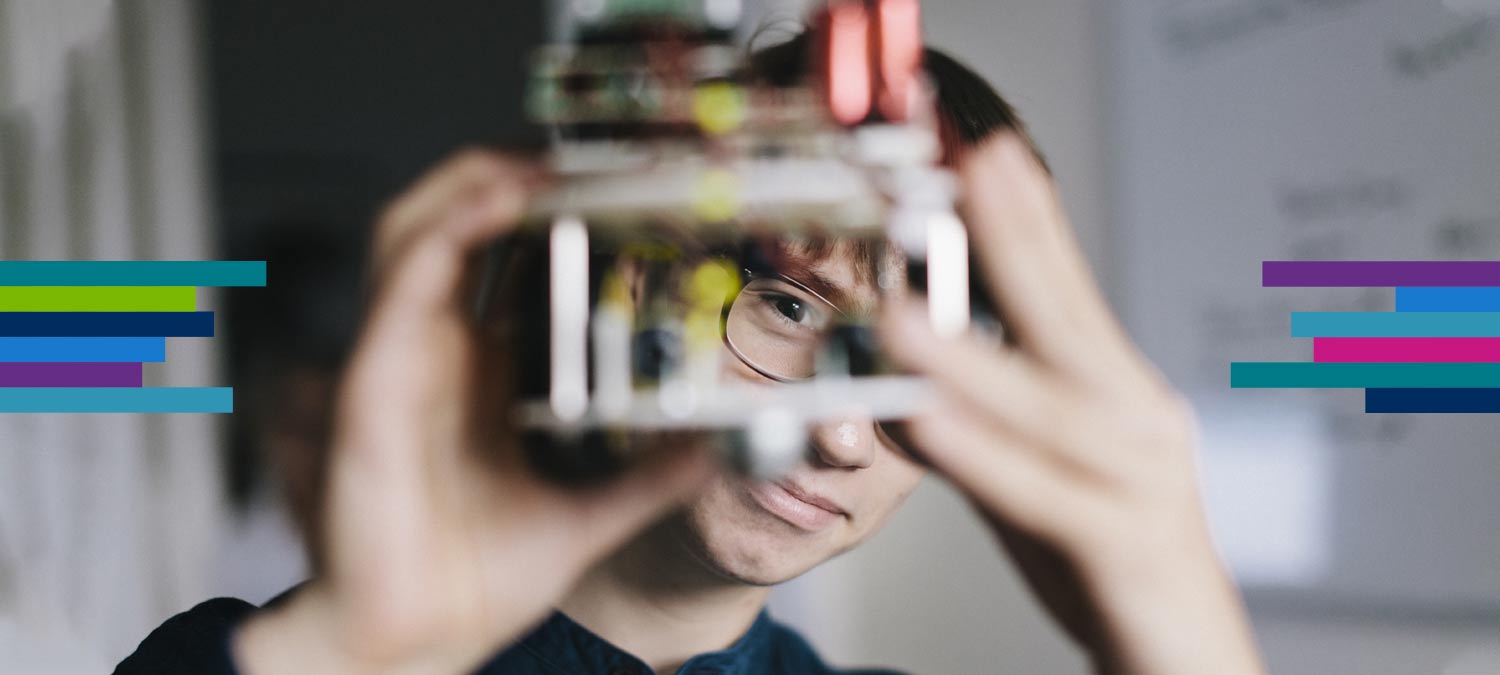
1292 312 1500 338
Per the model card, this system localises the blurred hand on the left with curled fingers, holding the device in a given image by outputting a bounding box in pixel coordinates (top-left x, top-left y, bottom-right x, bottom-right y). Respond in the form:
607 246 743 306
234 152 711 674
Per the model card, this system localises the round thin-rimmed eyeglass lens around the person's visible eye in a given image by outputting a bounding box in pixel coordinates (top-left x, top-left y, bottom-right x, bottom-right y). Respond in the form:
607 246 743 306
725 269 849 383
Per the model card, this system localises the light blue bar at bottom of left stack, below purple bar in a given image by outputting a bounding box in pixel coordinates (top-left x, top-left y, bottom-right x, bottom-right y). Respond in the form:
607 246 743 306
0 387 234 413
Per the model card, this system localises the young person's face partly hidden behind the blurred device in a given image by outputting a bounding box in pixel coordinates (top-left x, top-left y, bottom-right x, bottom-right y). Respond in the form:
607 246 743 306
672 243 924 585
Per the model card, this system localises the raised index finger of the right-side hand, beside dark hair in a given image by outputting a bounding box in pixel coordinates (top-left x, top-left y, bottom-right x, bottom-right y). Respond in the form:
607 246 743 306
960 134 1124 379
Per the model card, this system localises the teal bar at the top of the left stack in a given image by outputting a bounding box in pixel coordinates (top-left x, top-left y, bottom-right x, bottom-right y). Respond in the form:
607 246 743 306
0 260 266 287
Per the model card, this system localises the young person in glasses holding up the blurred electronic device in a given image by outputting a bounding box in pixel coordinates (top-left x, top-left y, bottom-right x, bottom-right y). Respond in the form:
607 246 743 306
117 41 1262 675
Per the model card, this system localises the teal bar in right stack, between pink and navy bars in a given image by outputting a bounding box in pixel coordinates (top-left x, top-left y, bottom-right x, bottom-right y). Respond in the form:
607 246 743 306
1229 362 1500 389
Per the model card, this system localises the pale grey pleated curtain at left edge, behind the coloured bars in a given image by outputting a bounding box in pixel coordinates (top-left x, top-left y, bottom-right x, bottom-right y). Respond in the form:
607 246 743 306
0 0 222 674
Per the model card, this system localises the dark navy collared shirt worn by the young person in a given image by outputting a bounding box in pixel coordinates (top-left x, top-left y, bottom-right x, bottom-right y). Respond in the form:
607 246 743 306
114 597 893 675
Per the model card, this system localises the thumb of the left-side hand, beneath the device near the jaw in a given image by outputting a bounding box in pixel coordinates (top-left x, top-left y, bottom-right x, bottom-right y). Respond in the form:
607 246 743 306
567 447 719 555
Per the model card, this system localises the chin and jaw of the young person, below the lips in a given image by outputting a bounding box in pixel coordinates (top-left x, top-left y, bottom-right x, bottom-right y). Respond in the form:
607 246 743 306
677 476 857 587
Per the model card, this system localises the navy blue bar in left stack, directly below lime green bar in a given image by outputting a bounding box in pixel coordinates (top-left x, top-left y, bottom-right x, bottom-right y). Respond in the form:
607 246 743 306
0 312 213 338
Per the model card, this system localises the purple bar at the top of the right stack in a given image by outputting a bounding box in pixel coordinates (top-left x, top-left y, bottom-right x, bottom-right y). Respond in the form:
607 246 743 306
1260 260 1500 288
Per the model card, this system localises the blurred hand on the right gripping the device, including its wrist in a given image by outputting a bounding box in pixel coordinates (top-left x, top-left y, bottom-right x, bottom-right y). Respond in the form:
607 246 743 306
882 134 1262 675
